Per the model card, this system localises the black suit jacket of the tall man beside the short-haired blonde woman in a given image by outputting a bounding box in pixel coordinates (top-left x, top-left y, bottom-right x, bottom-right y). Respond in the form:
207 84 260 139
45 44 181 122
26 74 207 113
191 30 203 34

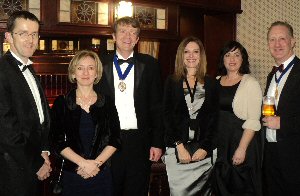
95 53 164 148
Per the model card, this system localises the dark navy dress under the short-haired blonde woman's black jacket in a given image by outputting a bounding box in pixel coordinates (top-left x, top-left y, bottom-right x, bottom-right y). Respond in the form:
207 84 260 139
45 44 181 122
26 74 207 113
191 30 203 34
62 109 112 196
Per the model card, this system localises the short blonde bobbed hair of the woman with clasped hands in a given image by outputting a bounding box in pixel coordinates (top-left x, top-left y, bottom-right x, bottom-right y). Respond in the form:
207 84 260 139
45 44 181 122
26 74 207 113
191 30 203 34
68 50 103 84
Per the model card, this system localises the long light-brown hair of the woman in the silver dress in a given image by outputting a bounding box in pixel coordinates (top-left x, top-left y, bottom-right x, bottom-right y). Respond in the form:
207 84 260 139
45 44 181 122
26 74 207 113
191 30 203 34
174 36 207 83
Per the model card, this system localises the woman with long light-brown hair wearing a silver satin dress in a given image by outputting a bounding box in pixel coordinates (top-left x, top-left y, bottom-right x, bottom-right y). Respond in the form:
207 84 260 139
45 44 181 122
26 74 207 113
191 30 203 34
164 37 217 196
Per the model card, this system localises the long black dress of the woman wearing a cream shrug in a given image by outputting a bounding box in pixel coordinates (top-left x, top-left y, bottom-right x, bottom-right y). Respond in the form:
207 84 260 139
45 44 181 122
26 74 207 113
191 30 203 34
214 80 261 196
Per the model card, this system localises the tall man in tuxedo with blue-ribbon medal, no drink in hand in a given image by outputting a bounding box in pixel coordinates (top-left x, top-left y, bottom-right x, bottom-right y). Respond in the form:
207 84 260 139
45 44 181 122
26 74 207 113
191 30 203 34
96 17 163 196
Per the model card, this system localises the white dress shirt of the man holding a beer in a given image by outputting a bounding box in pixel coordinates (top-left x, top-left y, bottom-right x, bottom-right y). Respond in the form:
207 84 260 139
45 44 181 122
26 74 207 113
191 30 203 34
266 55 295 142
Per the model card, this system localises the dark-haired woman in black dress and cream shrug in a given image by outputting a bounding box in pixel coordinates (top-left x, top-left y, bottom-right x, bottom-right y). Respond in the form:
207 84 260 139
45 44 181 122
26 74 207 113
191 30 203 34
214 41 262 196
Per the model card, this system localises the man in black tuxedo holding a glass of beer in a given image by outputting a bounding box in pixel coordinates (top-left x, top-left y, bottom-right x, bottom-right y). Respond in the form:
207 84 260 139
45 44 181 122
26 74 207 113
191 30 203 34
263 21 300 196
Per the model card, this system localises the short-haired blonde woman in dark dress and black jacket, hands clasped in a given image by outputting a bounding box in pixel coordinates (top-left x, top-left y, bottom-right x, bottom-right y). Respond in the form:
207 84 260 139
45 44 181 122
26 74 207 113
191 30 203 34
51 50 120 196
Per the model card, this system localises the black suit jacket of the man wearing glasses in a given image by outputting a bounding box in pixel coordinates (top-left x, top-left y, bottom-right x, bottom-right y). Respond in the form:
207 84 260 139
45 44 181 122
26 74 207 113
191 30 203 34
0 51 49 196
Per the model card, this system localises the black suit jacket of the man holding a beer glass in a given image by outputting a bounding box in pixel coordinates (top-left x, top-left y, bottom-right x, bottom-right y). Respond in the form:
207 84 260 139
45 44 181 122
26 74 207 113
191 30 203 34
265 57 300 185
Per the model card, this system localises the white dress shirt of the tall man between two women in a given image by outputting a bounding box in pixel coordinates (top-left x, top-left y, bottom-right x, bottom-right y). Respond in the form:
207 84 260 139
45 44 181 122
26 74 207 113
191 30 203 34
113 52 138 130
